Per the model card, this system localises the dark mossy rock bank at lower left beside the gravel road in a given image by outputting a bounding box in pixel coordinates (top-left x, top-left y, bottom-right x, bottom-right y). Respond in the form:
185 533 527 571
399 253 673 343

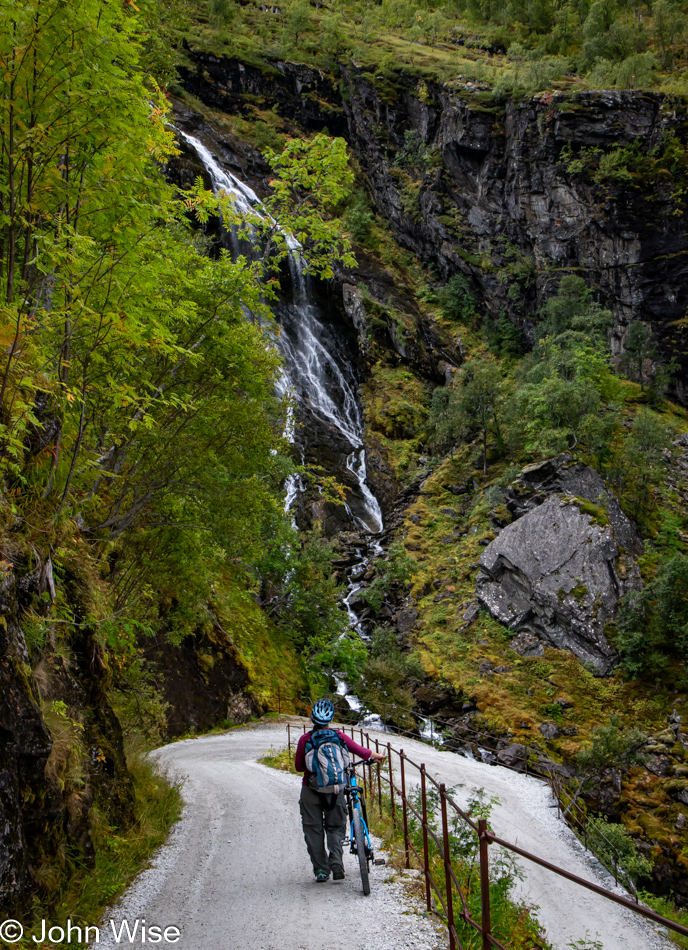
0 562 133 914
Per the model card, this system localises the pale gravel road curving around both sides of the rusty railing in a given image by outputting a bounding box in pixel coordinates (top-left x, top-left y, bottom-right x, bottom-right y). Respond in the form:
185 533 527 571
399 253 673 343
99 724 671 950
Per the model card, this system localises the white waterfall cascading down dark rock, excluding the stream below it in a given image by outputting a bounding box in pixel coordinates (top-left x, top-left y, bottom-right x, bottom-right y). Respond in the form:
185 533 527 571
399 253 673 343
177 129 383 534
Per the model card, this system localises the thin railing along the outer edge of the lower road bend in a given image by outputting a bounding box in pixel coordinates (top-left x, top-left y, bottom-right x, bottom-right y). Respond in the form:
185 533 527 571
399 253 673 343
338 702 638 901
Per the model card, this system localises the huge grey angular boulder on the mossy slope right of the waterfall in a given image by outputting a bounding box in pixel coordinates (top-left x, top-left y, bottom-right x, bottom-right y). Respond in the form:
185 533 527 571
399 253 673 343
476 495 640 675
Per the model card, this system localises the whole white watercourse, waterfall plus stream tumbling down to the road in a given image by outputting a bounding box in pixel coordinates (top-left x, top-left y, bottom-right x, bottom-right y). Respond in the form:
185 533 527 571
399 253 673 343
177 129 437 739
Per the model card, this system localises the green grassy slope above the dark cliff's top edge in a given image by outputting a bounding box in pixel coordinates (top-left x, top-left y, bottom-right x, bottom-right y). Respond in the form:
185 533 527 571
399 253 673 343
179 0 688 98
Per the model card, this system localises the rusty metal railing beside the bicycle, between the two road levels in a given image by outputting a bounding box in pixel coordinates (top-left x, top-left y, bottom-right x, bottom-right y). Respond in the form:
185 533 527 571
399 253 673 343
287 723 688 950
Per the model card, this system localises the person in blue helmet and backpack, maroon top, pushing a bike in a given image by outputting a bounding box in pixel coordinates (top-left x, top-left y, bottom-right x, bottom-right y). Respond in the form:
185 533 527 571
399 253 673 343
294 699 385 884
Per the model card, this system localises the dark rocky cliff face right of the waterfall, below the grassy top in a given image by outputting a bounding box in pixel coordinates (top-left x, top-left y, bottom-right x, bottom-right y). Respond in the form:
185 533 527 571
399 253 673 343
183 52 688 399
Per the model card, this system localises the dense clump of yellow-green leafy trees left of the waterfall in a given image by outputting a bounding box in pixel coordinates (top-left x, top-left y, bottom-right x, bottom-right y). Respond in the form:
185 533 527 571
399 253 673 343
0 0 296 648
